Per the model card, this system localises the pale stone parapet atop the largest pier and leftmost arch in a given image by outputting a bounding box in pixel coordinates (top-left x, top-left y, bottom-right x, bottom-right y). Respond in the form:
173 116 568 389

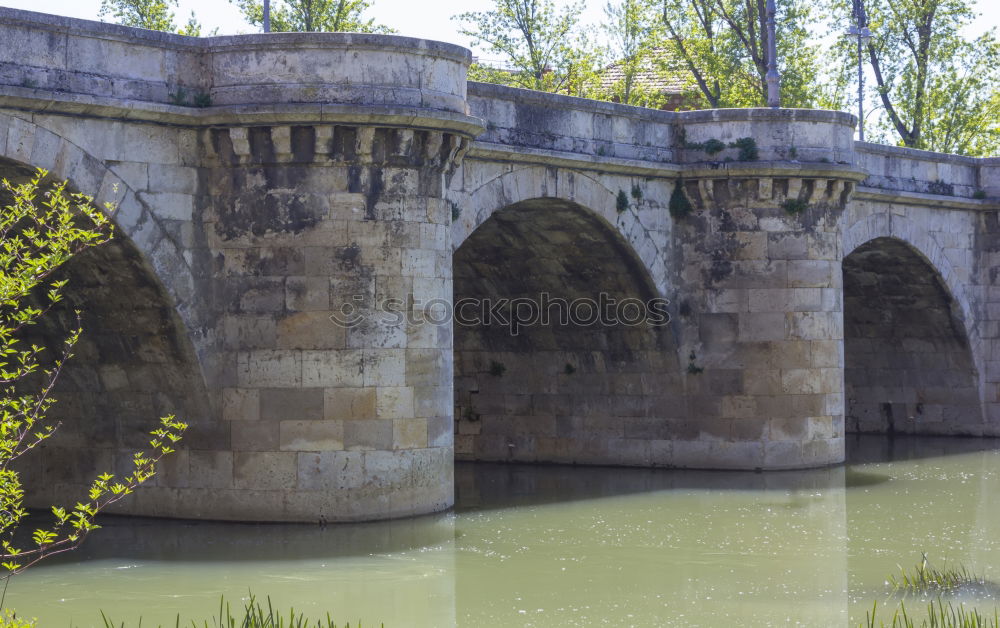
0 8 481 135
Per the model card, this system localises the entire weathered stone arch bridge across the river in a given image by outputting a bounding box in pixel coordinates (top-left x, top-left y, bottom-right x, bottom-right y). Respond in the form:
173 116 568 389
0 9 1000 521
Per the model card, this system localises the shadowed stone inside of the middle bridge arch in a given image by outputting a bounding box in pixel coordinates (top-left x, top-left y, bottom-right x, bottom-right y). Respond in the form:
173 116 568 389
453 197 685 465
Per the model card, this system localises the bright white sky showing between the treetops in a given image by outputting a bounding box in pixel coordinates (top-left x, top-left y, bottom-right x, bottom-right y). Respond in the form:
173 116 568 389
0 0 1000 58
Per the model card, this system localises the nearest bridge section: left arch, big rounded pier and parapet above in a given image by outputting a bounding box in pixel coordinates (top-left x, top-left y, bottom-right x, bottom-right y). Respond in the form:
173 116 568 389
0 10 481 521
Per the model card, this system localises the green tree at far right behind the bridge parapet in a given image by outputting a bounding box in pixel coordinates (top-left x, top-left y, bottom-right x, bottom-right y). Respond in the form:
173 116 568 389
833 0 1000 155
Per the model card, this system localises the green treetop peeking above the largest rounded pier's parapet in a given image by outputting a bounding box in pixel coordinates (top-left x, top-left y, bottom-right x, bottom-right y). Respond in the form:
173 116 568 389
230 0 395 33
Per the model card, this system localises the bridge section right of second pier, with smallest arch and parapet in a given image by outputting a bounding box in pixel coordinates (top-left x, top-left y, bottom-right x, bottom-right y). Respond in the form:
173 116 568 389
843 144 1000 435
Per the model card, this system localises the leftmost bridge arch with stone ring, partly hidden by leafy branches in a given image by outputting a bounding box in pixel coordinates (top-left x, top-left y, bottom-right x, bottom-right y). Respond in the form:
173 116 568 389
0 113 211 514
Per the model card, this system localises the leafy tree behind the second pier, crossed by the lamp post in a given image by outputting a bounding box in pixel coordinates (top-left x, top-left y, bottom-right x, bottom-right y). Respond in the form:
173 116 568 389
663 0 818 108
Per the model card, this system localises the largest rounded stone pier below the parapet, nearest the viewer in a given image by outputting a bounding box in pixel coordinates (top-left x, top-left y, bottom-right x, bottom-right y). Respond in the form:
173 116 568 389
204 125 462 519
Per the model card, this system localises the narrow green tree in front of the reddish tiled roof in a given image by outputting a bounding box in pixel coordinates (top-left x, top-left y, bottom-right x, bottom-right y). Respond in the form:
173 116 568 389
601 0 664 107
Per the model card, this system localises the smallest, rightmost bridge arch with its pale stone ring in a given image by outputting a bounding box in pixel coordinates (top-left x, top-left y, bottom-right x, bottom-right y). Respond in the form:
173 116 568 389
843 214 988 435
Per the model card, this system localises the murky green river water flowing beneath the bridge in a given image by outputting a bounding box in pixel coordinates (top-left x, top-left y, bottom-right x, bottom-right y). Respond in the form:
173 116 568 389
6 437 1000 628
